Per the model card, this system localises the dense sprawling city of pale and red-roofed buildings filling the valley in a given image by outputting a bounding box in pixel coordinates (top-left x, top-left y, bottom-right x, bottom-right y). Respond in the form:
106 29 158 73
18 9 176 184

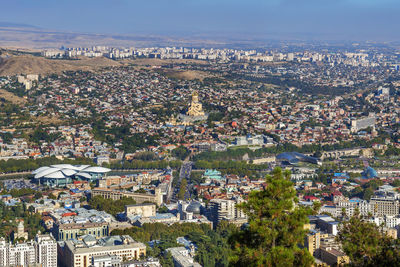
0 43 400 267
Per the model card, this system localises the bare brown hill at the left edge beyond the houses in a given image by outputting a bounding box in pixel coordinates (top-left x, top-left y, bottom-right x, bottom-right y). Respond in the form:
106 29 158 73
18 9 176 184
0 55 120 76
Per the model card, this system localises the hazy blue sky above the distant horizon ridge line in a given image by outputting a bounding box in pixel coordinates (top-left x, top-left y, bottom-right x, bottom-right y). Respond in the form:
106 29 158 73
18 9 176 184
0 0 400 41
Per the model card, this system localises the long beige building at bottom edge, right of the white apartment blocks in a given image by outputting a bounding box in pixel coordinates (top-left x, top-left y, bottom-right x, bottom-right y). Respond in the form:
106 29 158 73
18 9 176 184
60 235 146 267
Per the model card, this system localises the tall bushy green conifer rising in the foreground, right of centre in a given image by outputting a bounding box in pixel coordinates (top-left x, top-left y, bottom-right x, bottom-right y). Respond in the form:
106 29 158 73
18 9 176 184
230 168 314 266
